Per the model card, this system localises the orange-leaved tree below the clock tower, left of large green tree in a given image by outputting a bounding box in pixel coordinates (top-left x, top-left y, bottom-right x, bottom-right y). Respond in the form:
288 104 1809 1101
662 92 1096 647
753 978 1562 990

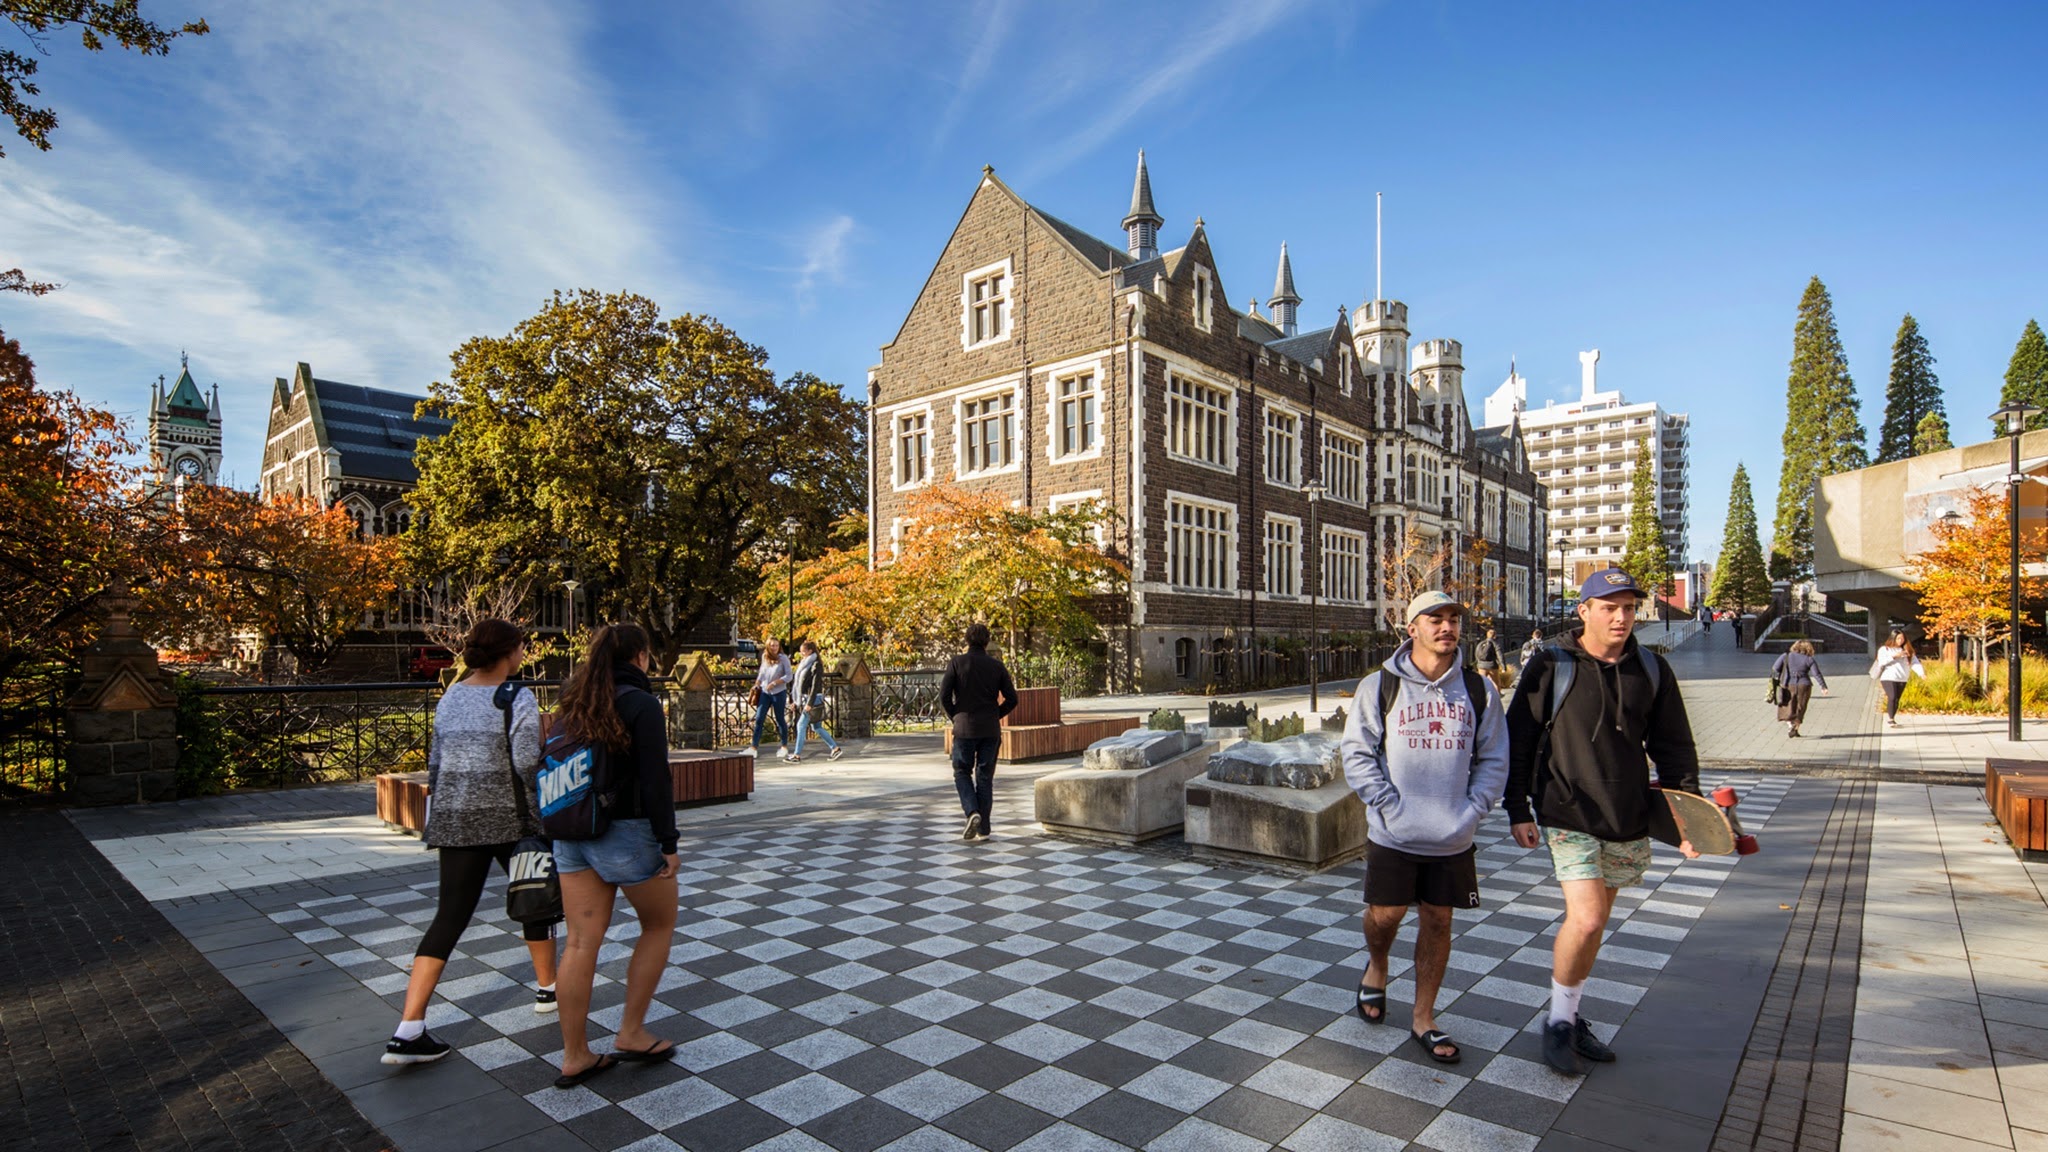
139 484 399 674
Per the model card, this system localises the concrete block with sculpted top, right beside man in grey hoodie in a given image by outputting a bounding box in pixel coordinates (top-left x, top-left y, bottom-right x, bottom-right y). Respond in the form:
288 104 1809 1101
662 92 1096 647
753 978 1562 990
1184 732 1366 871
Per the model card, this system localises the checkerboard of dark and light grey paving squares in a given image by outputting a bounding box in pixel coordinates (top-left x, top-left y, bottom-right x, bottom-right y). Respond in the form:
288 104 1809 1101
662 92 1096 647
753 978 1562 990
272 777 1790 1152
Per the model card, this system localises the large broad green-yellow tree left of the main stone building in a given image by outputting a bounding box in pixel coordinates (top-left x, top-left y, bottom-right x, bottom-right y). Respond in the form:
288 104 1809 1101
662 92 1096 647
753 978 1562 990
408 291 866 658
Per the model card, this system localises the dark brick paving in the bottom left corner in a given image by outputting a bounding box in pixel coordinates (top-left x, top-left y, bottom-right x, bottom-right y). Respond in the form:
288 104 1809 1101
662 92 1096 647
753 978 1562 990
0 812 389 1152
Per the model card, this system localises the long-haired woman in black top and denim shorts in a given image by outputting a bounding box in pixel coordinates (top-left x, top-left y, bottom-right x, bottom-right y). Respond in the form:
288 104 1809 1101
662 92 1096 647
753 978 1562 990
549 623 676 1088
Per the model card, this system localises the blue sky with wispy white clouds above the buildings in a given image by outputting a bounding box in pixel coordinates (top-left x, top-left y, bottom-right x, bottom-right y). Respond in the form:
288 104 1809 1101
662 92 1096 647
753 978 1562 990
0 0 2048 560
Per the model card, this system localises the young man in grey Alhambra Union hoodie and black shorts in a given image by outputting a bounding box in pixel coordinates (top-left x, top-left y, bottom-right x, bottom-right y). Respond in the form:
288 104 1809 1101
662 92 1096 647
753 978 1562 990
1343 592 1507 1064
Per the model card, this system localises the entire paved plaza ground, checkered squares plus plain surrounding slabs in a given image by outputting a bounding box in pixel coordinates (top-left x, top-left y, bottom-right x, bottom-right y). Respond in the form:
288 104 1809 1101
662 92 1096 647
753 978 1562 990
24 629 2048 1152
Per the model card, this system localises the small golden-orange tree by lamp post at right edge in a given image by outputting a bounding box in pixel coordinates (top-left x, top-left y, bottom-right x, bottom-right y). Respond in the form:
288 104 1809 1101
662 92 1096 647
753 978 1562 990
1901 481 2048 683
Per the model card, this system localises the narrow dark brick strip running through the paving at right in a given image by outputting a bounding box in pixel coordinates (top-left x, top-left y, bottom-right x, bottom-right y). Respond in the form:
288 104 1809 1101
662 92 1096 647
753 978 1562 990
1714 781 1876 1152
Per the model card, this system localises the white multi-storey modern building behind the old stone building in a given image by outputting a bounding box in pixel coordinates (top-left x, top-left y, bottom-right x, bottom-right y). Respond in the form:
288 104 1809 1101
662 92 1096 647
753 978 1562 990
1487 348 1692 592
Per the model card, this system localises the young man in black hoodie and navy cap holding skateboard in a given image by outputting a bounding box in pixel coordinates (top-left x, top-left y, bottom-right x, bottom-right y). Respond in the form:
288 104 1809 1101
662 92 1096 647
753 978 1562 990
1503 568 1700 1076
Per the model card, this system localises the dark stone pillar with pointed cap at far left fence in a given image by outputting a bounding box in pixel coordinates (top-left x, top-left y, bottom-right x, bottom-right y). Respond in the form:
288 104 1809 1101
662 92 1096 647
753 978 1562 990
63 592 178 804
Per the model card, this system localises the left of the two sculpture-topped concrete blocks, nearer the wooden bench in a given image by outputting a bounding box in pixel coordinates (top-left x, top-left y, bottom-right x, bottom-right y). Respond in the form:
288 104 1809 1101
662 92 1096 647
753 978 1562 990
1032 726 1217 845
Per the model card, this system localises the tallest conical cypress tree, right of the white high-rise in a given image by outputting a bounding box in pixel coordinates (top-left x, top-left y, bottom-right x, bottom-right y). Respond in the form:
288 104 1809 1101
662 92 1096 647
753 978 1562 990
1769 277 1870 580
